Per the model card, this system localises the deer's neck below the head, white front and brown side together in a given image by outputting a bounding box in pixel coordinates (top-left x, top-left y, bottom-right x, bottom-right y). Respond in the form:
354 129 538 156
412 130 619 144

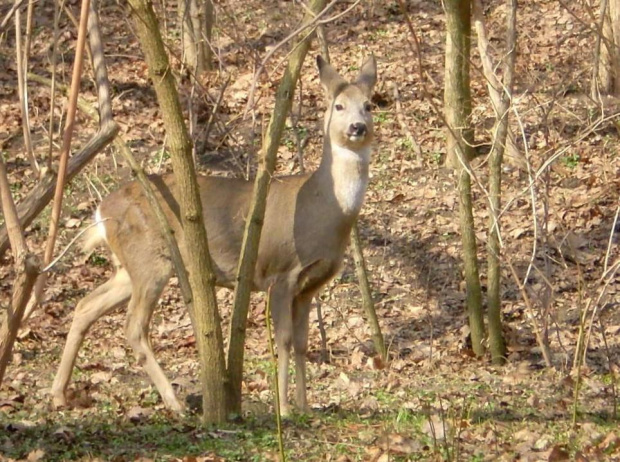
315 136 370 217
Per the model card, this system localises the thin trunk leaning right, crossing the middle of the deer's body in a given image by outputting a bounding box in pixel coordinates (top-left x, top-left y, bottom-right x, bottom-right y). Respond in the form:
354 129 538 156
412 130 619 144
228 0 327 413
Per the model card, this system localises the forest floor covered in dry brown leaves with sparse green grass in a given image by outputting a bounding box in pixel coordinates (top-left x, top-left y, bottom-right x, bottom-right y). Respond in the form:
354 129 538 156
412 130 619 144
0 0 620 462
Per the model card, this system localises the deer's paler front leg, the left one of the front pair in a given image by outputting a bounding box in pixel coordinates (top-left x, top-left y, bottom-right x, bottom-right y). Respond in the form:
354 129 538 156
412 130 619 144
270 282 293 417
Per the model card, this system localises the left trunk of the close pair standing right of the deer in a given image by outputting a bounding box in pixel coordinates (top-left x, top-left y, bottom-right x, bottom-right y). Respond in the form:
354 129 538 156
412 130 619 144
444 0 484 356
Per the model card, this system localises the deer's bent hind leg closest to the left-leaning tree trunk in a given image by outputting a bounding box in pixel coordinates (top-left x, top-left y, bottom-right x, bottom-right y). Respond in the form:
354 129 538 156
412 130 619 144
125 272 184 412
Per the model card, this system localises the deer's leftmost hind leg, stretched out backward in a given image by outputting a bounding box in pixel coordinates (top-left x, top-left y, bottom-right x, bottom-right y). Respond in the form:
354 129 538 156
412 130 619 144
51 268 131 406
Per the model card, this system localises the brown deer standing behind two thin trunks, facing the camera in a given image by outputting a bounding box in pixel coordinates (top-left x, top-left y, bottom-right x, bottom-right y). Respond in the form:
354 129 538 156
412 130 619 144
51 55 377 416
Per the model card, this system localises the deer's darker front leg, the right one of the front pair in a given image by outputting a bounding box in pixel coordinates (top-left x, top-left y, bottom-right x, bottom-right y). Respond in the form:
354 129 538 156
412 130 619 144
293 292 314 412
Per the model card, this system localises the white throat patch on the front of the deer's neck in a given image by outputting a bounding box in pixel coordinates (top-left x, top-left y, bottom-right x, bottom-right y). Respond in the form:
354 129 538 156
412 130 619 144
331 144 370 215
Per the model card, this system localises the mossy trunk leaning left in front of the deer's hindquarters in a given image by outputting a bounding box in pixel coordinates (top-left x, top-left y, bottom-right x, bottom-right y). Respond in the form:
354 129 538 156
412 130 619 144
129 0 228 423
